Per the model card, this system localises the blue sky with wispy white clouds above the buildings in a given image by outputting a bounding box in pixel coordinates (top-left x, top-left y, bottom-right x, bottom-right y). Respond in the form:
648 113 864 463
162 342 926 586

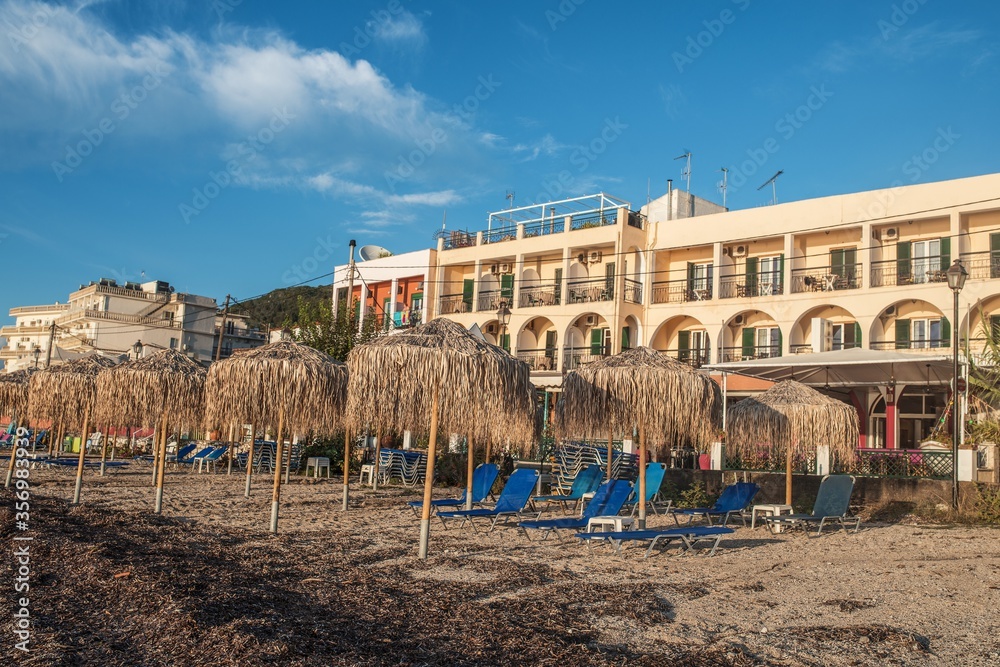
0 0 1000 321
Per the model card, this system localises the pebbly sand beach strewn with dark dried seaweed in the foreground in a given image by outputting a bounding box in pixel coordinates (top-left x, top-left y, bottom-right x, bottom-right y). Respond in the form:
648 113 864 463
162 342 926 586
2 469 1000 666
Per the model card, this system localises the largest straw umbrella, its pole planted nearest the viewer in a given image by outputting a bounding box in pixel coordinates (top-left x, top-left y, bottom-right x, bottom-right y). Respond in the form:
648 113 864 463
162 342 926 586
347 318 536 558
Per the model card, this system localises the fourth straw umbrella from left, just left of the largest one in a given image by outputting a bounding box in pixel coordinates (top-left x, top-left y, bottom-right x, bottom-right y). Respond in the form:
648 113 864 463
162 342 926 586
205 341 347 533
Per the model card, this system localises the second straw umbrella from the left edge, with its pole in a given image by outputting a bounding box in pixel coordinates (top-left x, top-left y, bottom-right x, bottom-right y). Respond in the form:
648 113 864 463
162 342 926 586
28 354 118 505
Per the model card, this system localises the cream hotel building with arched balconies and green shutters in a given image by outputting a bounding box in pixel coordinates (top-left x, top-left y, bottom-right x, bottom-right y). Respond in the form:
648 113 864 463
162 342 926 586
429 174 1000 448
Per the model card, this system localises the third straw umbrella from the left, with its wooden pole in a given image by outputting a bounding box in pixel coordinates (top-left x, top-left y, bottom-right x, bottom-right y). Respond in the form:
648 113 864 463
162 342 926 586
97 350 208 514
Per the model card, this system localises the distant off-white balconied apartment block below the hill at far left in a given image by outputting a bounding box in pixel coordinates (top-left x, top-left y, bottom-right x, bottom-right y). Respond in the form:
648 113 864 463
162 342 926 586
0 279 266 371
